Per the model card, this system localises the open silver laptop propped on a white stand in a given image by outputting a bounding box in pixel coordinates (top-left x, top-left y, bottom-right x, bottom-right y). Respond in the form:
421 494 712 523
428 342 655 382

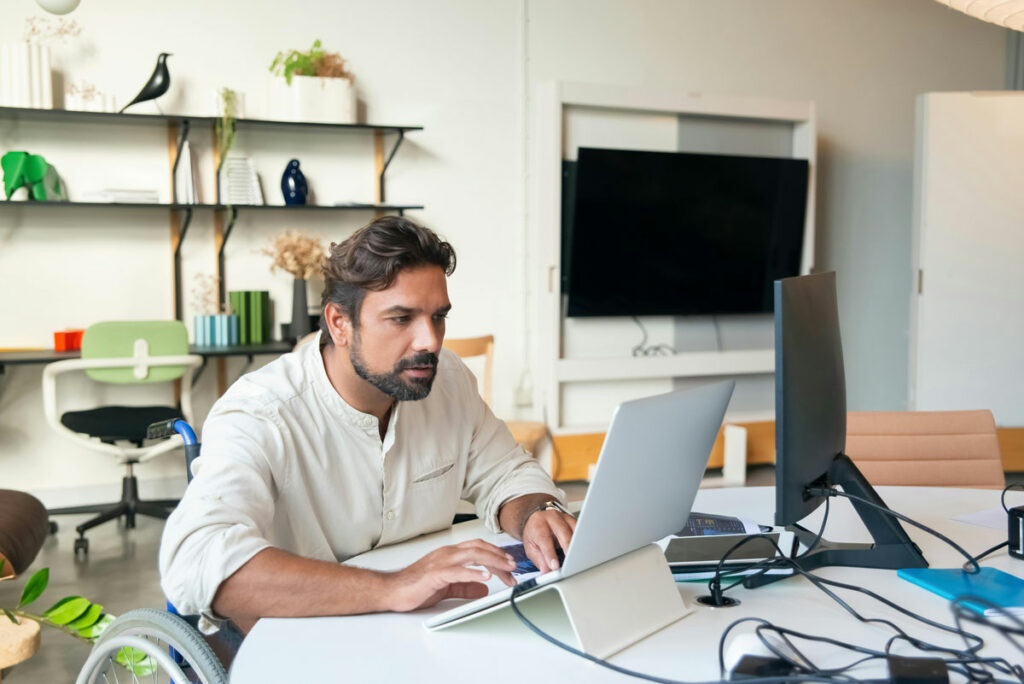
425 380 736 629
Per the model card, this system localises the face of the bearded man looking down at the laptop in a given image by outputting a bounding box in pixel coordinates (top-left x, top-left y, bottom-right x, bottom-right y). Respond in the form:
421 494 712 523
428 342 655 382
348 266 452 401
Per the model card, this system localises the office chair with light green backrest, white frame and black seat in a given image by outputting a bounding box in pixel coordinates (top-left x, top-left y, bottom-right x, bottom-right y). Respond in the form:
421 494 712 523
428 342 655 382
43 320 203 555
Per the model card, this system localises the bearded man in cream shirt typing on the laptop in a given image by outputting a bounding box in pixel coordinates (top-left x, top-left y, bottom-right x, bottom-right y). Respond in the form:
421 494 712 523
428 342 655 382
160 217 575 632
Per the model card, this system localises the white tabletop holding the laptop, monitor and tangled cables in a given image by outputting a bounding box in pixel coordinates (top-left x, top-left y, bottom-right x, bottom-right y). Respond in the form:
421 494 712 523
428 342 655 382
231 487 1024 684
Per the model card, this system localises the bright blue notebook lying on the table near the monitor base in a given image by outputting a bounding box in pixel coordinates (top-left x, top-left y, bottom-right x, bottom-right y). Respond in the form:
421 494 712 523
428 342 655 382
896 567 1024 616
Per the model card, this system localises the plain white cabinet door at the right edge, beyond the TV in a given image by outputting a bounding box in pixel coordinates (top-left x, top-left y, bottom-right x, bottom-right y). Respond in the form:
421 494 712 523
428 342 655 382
910 92 1024 426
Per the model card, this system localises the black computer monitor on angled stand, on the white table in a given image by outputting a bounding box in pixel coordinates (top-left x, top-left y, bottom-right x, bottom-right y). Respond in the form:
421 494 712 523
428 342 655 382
775 272 928 569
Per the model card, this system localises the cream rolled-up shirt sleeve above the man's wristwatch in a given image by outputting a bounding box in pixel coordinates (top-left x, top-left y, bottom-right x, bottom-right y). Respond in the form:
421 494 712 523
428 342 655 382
462 367 565 532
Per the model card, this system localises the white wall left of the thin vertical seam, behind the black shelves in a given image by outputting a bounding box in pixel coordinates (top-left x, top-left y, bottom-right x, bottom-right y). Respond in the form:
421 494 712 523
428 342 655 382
0 0 524 503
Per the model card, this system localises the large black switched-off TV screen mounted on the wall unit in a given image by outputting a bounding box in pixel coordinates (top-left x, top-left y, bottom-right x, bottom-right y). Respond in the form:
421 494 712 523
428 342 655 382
562 147 808 316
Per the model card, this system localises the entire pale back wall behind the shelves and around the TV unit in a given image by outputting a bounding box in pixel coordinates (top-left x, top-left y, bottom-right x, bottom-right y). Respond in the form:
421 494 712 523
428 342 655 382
0 0 1005 497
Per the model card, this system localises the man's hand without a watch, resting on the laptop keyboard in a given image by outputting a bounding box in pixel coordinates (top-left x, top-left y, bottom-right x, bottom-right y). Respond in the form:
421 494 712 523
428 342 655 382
387 540 516 612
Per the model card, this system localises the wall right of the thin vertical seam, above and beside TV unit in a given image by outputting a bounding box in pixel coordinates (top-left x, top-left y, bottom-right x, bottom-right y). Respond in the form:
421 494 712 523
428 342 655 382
527 0 1006 417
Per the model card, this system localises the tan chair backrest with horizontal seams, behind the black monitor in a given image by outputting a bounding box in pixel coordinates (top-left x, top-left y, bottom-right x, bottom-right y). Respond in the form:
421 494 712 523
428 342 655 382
846 411 1006 489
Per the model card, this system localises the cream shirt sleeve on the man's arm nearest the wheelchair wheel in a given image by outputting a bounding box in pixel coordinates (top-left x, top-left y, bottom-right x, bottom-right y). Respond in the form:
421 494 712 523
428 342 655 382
160 411 281 632
